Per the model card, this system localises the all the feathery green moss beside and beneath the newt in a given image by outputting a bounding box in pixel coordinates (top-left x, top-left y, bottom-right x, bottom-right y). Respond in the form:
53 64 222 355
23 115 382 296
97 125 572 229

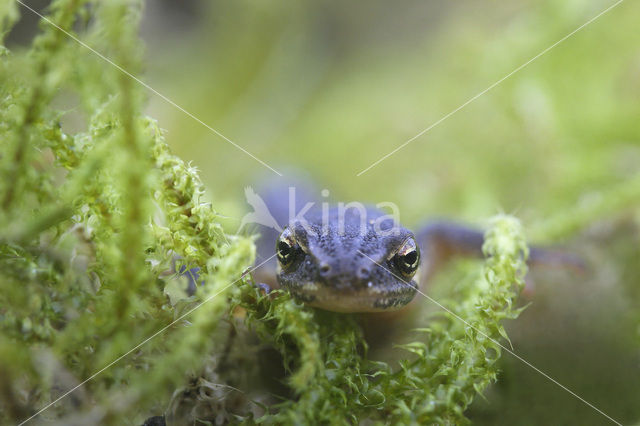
0 0 639 424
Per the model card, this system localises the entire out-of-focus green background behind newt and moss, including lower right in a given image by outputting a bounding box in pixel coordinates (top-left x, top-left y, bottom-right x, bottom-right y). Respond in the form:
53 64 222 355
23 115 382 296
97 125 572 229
132 0 640 424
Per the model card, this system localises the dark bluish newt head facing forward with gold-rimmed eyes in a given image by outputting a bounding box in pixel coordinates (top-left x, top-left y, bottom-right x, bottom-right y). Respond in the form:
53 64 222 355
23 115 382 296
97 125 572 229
276 208 420 312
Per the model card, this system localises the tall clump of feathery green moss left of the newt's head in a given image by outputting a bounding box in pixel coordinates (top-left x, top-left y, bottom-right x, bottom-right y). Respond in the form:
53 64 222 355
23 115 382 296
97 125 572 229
0 1 254 424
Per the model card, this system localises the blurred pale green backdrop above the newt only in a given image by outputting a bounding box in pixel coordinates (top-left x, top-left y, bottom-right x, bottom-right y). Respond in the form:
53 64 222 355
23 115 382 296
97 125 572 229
143 1 640 223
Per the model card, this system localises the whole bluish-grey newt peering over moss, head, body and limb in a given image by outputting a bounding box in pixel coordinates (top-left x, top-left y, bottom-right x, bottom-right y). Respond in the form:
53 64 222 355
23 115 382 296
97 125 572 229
248 176 582 313
